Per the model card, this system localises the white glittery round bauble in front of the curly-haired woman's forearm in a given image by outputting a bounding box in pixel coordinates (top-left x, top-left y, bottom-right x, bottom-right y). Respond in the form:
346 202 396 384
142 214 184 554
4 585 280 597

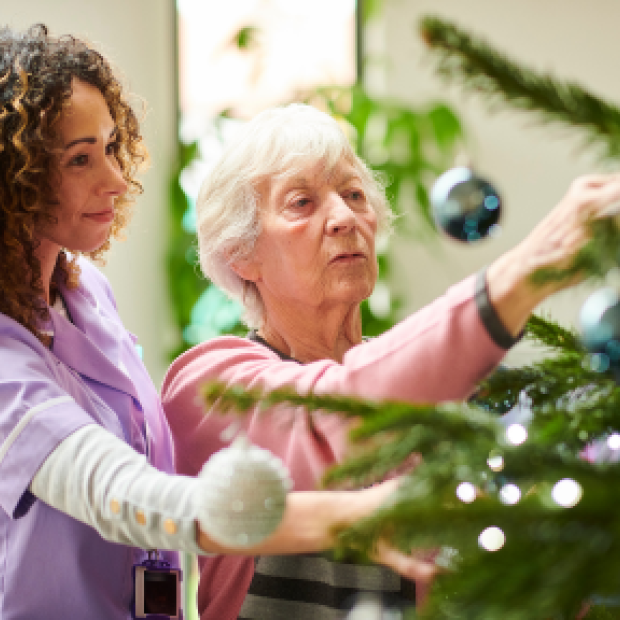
199 434 293 547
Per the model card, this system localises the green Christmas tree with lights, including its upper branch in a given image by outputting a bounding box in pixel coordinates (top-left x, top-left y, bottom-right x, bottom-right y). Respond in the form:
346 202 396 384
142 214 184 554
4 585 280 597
205 18 620 620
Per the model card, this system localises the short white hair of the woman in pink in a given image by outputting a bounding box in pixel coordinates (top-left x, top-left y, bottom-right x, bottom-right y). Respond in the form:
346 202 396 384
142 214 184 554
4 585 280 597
196 103 393 327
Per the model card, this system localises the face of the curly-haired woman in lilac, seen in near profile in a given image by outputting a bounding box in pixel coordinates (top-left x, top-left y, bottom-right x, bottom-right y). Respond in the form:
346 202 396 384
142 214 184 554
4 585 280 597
39 79 127 252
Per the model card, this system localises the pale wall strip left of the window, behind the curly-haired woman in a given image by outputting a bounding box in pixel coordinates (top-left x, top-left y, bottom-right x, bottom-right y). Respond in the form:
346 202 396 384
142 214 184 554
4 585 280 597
0 0 176 385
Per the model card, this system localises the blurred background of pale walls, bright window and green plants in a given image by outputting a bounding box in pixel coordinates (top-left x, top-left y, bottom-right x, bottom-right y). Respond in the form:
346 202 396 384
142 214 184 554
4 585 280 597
0 0 620 618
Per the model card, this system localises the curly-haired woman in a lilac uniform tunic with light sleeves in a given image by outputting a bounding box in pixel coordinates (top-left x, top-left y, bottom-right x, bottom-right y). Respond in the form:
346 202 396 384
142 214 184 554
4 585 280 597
0 26 433 620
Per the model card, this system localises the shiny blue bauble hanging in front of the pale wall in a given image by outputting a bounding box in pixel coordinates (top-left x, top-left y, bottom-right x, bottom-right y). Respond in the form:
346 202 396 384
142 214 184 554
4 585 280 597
431 168 502 243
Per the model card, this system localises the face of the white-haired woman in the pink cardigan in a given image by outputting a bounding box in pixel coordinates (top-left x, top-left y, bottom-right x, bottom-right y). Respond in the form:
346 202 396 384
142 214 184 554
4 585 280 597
242 161 377 310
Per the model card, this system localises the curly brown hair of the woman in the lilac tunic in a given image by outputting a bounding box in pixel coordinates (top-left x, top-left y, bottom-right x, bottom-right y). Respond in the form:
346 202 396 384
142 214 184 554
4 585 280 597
0 24 148 344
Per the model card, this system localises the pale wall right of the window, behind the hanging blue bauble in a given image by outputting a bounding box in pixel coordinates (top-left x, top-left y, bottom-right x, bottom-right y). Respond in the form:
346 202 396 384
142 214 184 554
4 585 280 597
376 0 620 366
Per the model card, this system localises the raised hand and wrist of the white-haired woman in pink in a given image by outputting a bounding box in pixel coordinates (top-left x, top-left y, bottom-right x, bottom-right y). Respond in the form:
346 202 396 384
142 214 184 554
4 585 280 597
487 174 620 336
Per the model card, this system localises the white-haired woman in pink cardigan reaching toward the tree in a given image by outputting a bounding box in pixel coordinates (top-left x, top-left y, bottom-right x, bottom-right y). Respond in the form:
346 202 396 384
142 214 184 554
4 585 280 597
162 105 620 620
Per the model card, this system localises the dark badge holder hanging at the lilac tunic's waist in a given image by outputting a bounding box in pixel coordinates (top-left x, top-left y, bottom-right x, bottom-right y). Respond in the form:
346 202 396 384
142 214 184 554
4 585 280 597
131 549 183 620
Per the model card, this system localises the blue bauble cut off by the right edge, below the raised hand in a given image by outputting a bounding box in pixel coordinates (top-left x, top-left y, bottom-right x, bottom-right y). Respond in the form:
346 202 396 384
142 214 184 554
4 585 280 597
579 287 620 381
